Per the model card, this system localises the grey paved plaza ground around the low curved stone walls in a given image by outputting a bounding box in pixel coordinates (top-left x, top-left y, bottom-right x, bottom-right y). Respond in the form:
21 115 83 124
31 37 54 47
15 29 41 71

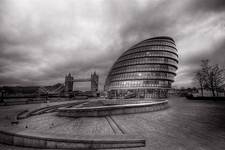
0 98 225 150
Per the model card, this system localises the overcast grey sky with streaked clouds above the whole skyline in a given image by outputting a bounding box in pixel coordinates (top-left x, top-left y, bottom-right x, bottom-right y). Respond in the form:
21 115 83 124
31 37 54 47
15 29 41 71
0 0 225 88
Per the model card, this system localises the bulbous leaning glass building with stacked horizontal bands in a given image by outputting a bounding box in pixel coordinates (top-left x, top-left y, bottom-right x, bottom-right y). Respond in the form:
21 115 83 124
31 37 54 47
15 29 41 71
105 36 178 98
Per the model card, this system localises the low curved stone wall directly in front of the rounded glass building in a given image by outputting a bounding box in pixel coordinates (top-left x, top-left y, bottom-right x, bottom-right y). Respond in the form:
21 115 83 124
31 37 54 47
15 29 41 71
57 100 168 117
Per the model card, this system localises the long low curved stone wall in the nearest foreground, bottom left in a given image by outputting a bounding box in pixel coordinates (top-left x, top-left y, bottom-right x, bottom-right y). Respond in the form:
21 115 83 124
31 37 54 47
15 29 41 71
0 128 145 149
